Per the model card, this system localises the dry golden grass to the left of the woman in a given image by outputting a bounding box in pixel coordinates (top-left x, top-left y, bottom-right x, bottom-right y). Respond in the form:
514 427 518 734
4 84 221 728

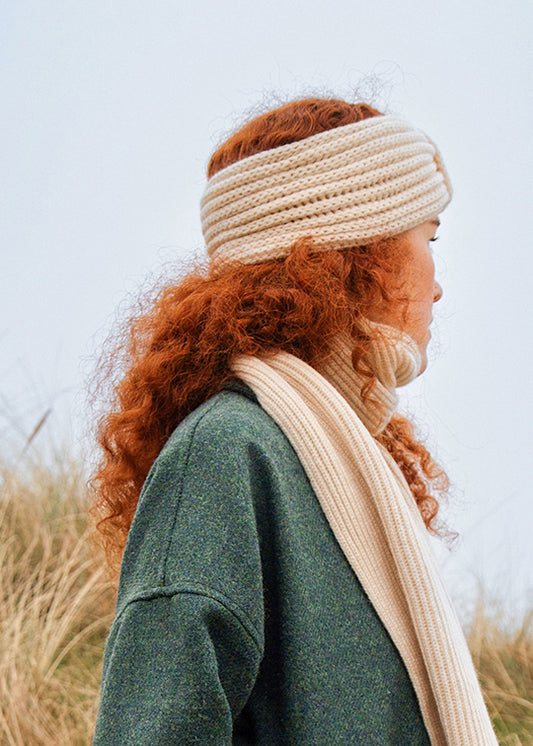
0 460 112 746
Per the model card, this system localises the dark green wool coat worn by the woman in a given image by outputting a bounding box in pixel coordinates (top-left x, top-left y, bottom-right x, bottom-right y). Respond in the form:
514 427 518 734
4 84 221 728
94 382 429 746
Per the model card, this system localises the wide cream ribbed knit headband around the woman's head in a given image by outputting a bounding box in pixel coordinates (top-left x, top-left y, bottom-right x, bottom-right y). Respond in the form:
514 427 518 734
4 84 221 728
202 116 451 264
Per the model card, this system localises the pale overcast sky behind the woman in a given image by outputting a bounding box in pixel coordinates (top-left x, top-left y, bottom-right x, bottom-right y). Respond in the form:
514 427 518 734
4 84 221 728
0 0 533 614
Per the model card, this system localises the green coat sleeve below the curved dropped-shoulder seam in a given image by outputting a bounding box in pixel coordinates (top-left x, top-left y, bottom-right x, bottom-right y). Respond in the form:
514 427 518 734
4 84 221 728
94 587 260 746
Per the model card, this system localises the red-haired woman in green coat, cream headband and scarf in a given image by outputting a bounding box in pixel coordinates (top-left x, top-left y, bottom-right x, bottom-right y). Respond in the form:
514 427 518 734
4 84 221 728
93 99 496 746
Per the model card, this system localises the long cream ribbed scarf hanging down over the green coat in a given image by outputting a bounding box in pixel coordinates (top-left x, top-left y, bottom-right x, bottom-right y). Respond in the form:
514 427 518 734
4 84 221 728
233 332 497 746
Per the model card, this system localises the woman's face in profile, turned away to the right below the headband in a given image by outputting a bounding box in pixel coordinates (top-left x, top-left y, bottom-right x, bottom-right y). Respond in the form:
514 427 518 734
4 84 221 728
368 218 442 372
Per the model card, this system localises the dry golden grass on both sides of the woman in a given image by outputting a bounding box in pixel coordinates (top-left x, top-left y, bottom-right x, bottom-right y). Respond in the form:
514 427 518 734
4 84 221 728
0 444 533 746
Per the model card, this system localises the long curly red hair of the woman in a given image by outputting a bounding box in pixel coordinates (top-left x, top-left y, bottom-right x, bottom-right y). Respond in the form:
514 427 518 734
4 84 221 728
91 98 448 566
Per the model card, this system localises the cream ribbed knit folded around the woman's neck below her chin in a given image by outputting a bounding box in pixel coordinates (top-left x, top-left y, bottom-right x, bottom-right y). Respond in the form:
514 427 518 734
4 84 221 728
318 320 422 436
